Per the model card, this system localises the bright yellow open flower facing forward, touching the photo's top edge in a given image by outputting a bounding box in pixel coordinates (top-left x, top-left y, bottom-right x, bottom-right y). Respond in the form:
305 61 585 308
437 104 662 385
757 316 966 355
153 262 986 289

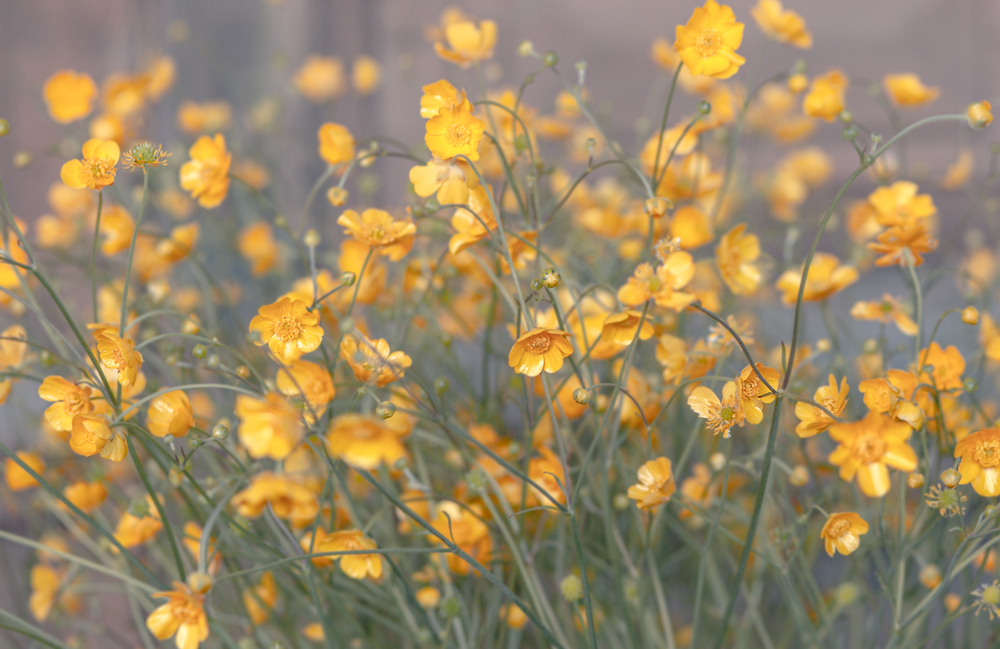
674 0 746 79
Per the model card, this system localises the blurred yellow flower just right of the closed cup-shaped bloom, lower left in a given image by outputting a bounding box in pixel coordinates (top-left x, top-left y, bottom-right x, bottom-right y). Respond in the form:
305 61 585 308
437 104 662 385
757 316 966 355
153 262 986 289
236 392 303 460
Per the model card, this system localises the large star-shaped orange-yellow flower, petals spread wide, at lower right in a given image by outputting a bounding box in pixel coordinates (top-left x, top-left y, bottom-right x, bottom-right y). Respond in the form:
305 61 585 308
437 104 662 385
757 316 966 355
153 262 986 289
830 412 917 498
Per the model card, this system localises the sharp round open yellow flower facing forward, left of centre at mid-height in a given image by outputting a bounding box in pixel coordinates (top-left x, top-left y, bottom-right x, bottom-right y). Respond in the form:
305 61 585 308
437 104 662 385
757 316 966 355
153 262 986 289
250 297 323 363
